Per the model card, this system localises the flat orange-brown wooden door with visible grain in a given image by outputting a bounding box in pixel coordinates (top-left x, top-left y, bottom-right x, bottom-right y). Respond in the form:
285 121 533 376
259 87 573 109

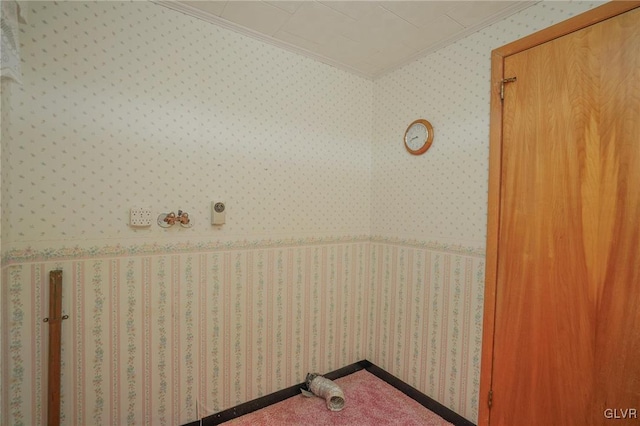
479 4 640 425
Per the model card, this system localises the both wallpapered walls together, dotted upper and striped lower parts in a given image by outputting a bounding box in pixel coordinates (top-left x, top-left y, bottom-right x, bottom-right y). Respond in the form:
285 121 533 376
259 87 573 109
0 2 591 425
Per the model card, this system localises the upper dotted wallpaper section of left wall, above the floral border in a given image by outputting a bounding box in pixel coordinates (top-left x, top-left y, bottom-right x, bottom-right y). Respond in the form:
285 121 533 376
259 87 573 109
2 2 373 250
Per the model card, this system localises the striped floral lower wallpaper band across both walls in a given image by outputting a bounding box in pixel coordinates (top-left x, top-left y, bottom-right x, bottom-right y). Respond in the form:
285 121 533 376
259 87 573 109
1 238 484 426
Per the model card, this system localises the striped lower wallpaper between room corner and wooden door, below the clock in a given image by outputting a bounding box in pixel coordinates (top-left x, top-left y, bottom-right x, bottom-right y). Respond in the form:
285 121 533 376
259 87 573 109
368 241 485 422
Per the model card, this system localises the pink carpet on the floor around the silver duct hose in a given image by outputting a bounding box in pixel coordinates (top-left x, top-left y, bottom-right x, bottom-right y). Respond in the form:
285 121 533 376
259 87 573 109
224 370 451 426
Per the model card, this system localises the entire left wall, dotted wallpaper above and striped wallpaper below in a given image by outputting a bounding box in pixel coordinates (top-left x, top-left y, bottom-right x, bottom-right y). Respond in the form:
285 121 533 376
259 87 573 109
0 2 373 426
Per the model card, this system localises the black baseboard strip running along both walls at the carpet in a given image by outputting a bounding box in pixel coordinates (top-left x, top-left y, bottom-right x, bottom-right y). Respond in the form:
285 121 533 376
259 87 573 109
184 360 475 426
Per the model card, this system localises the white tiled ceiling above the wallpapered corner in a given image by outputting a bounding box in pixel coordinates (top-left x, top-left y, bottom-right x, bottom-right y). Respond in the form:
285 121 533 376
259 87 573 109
156 0 536 78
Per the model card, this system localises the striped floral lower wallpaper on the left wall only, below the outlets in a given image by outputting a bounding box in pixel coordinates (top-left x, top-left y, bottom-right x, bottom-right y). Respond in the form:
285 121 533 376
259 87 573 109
2 241 370 426
